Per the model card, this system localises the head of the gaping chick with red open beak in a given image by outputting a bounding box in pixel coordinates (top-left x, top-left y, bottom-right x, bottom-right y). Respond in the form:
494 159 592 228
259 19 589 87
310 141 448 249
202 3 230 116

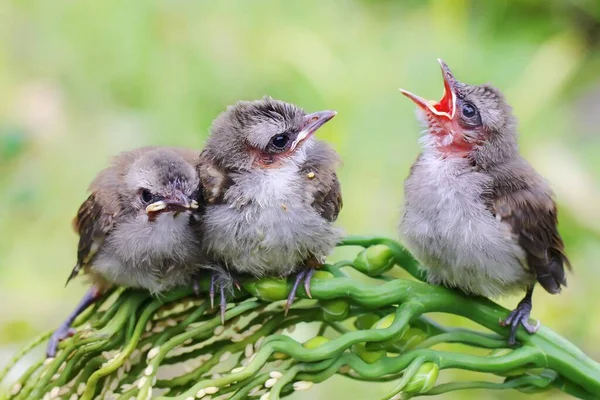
400 59 517 163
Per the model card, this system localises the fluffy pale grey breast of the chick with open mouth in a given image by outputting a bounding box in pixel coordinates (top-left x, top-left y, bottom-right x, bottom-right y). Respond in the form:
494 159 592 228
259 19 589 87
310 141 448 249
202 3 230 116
400 153 528 296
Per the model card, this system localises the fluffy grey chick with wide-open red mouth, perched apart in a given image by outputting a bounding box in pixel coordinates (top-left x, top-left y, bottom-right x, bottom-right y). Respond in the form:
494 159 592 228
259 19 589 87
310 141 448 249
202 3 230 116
399 59 571 345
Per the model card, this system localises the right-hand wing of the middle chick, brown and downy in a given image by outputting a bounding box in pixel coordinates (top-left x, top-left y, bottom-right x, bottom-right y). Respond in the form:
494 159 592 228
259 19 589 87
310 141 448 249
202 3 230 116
301 142 343 222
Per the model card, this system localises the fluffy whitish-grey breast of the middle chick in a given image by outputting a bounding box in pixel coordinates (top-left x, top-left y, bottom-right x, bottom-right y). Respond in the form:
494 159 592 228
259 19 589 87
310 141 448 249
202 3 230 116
203 170 341 275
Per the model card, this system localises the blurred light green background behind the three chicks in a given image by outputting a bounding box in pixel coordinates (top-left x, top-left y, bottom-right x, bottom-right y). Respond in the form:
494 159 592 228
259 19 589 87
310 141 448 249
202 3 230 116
0 0 600 399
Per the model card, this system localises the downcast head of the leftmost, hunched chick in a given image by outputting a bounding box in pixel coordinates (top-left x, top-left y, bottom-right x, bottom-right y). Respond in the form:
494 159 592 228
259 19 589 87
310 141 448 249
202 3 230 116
121 149 199 221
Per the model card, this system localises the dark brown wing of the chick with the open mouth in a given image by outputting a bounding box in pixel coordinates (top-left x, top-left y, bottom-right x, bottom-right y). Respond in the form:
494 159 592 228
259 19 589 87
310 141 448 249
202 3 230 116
492 187 571 293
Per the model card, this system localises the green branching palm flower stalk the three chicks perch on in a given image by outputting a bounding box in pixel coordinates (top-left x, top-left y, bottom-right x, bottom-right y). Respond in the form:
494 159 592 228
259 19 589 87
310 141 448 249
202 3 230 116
0 237 600 400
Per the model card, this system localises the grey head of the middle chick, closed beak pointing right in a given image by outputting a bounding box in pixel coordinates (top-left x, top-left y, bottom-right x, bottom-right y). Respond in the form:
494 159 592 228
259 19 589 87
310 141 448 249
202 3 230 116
206 97 336 170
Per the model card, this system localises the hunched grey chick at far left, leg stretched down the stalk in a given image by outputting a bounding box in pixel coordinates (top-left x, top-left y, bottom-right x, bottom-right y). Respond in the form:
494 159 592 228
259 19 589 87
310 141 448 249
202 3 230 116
46 147 202 357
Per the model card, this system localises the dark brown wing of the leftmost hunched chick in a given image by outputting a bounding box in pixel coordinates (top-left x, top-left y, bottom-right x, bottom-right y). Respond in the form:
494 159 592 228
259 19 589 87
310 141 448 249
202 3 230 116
67 193 117 283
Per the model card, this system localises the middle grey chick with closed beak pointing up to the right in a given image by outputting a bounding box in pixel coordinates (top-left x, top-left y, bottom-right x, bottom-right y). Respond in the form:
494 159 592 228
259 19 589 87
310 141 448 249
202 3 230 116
198 97 342 312
